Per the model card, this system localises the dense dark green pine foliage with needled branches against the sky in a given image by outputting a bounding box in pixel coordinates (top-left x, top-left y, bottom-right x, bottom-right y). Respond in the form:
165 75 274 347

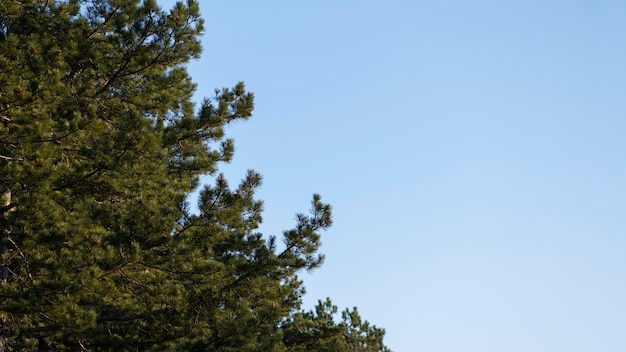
0 0 386 351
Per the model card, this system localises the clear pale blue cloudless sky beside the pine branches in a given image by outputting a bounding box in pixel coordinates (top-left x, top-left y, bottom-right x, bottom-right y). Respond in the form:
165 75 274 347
160 0 626 352
